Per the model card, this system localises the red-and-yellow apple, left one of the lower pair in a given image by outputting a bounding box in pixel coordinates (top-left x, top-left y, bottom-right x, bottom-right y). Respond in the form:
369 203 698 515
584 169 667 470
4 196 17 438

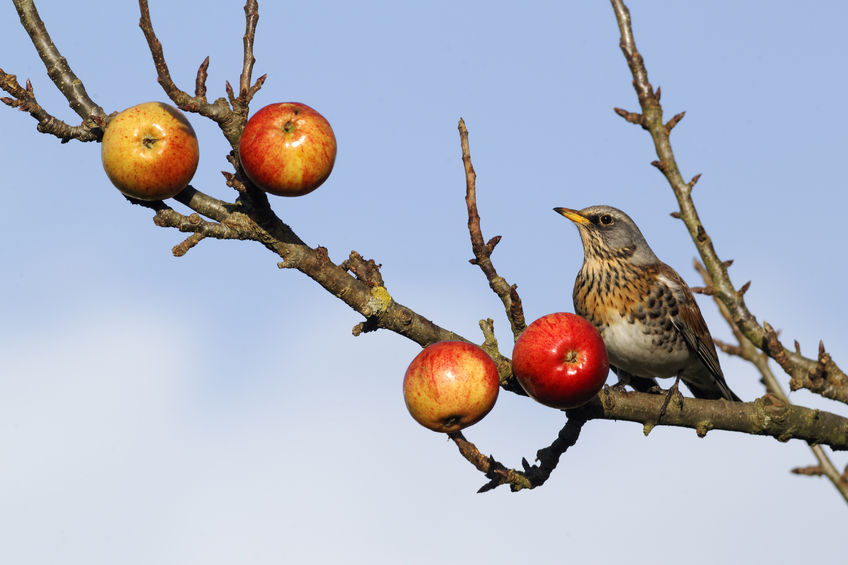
403 341 500 433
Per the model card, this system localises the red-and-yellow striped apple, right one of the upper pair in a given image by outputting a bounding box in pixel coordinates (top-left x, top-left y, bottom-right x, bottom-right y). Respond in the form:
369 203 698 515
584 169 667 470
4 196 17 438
239 102 336 196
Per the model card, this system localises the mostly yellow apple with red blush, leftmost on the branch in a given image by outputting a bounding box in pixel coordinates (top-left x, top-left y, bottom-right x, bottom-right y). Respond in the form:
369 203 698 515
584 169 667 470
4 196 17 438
100 102 200 200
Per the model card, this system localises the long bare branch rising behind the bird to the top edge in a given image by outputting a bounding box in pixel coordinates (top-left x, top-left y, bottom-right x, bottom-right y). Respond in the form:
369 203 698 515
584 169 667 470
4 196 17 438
610 0 848 403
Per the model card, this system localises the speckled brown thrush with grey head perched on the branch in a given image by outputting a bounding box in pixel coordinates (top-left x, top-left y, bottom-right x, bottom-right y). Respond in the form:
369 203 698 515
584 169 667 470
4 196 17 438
554 205 741 400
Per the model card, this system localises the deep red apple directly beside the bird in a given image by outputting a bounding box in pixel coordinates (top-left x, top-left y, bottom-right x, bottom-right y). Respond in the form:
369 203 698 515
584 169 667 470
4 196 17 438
512 312 609 409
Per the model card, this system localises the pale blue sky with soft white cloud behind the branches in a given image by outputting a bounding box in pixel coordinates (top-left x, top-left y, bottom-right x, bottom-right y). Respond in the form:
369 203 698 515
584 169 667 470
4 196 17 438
0 0 848 565
